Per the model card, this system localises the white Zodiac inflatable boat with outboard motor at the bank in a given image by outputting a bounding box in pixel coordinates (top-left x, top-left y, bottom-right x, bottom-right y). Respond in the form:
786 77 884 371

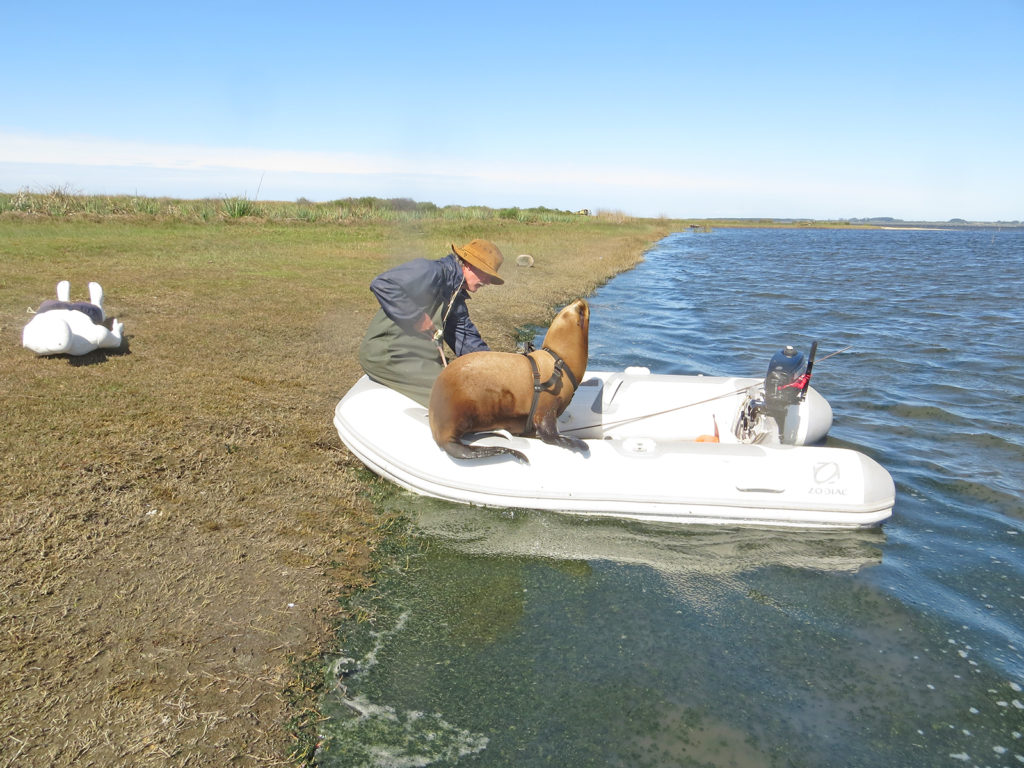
334 347 895 528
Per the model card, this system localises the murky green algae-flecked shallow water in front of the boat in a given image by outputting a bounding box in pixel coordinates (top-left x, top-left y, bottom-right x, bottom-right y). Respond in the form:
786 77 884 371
317 500 1024 768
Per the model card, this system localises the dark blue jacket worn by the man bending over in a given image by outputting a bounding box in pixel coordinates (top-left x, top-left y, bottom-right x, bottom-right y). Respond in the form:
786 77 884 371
370 253 489 355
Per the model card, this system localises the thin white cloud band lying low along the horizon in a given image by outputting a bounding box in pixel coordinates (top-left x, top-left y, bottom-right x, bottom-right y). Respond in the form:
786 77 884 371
0 132 995 220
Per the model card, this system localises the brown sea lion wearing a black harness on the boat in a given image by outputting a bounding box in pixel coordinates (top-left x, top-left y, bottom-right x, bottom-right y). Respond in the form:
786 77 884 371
429 299 590 464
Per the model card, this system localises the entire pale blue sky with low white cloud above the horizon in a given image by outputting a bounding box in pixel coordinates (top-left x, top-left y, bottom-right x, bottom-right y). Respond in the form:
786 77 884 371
0 0 1024 221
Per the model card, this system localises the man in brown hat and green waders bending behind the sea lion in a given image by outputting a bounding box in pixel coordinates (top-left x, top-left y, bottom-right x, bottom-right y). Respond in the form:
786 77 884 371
359 240 505 407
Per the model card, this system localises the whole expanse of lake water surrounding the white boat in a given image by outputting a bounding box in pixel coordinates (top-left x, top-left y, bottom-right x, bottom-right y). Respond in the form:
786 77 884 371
318 229 1024 768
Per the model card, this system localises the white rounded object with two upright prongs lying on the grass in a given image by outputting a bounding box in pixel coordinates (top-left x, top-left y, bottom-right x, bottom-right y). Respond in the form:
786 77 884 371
22 280 124 355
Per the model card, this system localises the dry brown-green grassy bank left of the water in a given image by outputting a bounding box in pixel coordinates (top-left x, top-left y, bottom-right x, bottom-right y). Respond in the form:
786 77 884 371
0 201 680 766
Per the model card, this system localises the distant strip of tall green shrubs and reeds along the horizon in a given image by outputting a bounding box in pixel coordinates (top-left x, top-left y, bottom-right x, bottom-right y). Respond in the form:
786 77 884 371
0 187 630 223
